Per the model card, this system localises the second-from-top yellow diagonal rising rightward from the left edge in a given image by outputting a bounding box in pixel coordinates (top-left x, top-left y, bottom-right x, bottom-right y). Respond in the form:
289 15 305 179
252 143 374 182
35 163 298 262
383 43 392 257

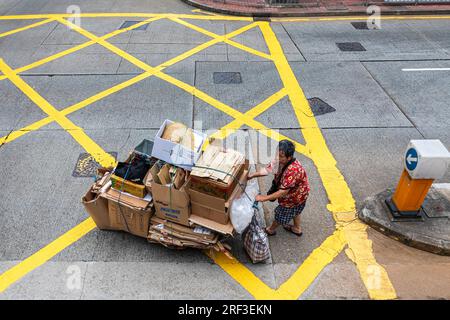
0 17 163 80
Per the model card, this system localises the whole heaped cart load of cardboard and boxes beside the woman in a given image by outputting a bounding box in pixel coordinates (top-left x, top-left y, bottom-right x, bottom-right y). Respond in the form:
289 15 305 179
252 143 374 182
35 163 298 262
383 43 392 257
82 120 248 254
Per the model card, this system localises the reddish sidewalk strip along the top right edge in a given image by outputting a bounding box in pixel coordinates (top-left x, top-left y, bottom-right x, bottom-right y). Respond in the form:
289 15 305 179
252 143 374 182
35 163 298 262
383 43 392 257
181 0 450 17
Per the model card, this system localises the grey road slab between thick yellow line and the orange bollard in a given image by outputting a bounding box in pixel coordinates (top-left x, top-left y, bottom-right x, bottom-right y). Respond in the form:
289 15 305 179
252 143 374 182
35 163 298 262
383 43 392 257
322 128 421 204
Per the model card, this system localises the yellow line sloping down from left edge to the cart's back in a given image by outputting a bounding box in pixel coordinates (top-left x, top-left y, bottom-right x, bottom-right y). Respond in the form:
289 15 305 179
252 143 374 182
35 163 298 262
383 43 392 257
0 59 116 167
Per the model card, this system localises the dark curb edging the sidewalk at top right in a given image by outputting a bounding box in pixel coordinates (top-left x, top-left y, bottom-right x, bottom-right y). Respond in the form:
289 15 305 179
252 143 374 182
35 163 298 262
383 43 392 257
181 0 450 18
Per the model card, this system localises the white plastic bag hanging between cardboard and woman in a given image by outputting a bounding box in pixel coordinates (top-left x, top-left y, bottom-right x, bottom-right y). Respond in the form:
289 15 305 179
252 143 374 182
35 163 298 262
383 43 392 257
230 179 259 234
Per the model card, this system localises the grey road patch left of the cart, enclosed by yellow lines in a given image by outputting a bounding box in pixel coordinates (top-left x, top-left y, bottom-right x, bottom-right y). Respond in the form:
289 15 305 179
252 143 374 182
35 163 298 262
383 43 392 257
0 130 99 260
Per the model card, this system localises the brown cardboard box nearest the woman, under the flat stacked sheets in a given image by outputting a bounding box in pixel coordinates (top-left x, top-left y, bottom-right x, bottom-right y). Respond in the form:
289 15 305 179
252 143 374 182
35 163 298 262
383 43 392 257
188 170 248 225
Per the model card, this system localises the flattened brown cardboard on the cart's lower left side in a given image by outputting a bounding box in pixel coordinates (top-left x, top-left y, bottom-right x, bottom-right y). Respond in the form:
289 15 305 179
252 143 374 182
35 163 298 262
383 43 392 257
100 188 154 238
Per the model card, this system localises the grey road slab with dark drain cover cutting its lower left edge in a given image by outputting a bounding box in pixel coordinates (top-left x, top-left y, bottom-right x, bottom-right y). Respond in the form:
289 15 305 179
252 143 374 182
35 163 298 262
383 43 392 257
290 62 412 128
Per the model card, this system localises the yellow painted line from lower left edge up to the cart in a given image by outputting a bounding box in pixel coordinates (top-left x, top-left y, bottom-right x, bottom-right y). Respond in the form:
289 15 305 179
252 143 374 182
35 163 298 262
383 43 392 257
0 218 95 293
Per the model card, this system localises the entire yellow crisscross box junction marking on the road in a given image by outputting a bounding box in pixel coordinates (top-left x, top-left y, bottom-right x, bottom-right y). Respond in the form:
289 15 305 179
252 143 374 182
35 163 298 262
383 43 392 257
0 14 395 299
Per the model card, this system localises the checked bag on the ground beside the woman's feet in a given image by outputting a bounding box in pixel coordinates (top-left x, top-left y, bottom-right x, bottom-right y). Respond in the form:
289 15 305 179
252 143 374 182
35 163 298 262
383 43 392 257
244 210 270 263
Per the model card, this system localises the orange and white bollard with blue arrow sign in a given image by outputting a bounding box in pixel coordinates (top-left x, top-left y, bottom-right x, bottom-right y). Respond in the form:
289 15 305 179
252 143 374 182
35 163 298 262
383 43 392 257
386 140 450 221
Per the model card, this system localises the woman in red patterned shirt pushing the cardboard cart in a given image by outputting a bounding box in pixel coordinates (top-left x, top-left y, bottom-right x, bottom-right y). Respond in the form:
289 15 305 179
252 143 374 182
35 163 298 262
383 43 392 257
248 140 310 236
